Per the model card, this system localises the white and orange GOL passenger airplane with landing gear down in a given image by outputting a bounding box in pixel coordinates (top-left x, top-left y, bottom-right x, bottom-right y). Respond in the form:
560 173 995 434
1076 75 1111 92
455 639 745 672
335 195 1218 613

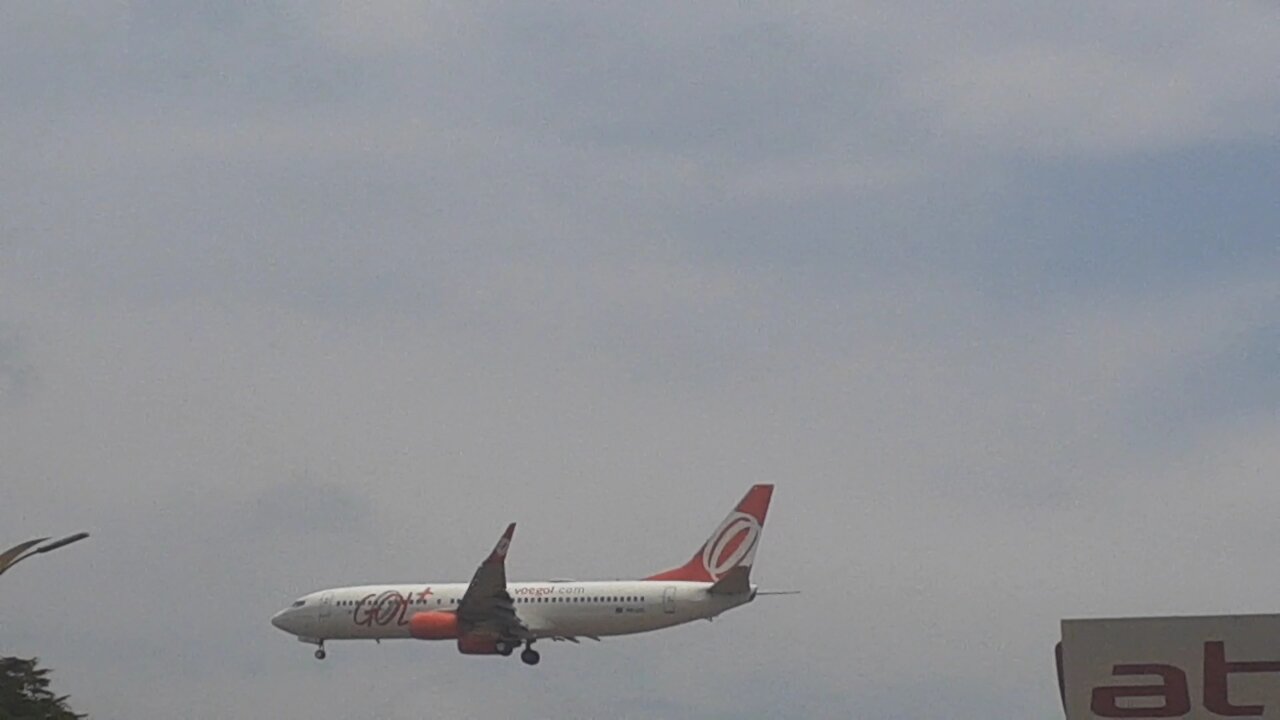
271 484 795 665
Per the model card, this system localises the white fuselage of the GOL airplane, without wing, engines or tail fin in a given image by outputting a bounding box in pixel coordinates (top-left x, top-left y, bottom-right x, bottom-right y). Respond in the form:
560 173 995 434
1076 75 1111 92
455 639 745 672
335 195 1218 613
271 580 755 642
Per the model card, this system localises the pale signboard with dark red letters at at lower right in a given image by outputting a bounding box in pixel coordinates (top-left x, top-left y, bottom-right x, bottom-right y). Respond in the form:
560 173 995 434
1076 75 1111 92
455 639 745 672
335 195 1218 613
1059 615 1280 720
